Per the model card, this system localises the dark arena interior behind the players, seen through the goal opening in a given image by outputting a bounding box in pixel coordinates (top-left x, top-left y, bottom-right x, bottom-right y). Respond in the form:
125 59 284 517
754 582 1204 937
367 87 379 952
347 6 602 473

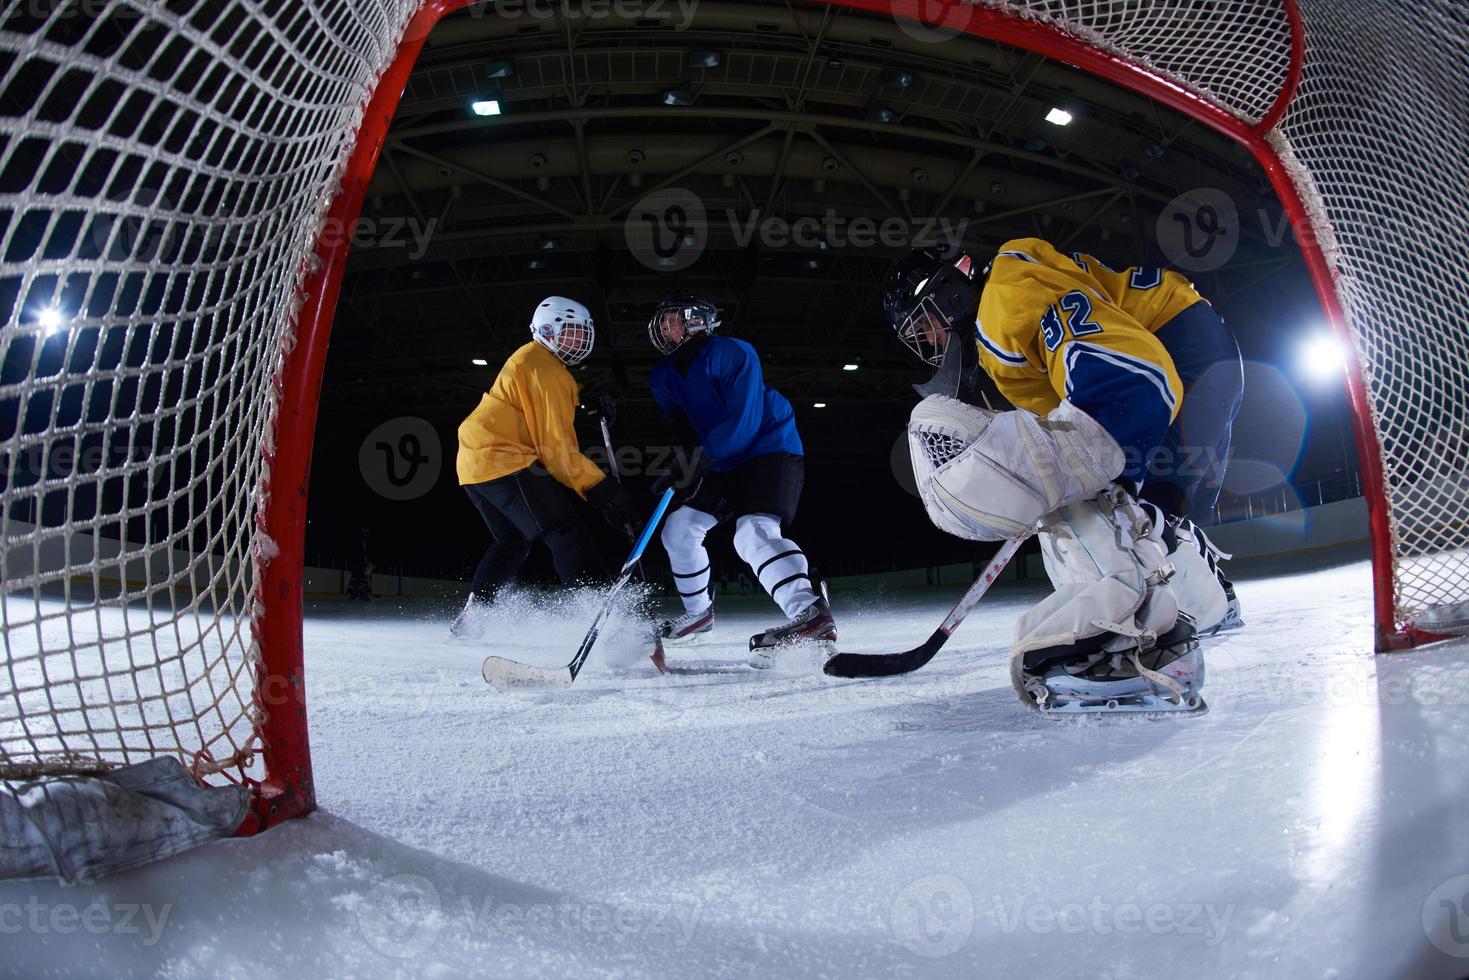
307 0 1360 590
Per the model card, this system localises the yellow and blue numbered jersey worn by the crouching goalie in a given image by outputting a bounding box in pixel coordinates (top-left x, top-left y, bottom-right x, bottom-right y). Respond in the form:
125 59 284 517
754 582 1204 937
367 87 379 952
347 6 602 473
977 238 1203 476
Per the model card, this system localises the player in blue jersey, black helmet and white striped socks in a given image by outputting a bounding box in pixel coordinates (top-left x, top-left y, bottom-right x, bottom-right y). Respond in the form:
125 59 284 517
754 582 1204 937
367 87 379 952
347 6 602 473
648 294 836 667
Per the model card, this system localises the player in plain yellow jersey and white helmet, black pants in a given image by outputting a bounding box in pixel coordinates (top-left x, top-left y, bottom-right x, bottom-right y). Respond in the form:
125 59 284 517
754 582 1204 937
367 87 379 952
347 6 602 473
451 297 643 638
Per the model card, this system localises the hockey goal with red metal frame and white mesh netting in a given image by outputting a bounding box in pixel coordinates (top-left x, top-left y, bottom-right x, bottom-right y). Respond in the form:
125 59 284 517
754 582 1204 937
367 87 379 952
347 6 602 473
0 0 1469 826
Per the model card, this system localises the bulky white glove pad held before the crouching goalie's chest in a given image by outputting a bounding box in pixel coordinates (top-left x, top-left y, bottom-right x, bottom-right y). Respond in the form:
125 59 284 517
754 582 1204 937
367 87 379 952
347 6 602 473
908 395 1124 541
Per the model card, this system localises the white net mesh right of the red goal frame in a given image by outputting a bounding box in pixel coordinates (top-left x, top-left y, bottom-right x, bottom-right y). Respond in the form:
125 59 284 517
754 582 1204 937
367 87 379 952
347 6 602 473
975 0 1469 629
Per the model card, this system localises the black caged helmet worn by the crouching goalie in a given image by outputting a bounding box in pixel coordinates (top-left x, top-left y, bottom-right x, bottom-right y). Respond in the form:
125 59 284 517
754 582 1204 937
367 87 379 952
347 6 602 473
883 248 981 364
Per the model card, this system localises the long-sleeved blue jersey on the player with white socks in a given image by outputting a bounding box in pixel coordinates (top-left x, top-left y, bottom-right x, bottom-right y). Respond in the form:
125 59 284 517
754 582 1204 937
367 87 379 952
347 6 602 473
648 336 804 473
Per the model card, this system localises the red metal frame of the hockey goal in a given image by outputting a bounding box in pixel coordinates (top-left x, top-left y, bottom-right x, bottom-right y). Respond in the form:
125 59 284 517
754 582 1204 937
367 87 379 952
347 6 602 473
241 0 1416 833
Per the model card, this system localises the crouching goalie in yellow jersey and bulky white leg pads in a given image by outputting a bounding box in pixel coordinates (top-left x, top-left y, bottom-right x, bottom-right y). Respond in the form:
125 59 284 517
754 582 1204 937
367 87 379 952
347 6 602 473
883 238 1243 713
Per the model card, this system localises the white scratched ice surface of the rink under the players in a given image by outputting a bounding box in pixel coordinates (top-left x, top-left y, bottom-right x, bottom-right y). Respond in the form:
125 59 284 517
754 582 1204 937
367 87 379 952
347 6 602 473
0 563 1469 980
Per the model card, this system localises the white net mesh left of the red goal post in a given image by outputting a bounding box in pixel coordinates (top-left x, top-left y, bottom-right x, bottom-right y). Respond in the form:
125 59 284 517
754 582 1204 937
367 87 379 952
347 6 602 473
0 0 417 779
